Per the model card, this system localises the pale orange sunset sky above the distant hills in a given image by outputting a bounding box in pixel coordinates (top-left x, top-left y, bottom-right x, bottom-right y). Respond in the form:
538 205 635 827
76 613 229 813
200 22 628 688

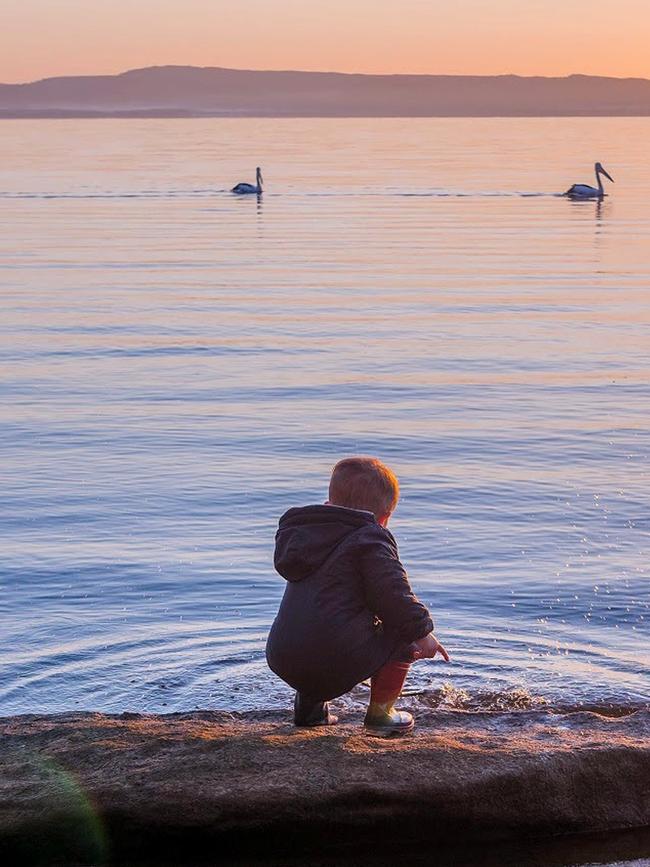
0 0 650 82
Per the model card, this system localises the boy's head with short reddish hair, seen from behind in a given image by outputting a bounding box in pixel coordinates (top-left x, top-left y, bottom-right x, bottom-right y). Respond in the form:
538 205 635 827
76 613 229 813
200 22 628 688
329 457 399 524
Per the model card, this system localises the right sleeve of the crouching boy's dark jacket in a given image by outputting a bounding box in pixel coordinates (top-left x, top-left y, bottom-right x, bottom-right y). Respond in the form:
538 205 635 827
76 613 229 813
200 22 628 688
359 532 433 643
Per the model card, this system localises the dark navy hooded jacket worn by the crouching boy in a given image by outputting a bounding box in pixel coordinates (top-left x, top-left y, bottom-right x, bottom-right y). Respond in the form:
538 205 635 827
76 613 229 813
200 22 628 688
266 506 433 700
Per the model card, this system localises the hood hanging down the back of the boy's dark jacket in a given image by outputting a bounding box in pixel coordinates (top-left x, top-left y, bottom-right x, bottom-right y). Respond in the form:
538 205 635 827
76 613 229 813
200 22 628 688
273 506 377 581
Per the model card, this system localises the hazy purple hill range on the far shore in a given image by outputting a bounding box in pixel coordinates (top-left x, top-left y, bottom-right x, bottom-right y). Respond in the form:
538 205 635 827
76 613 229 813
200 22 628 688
0 66 650 117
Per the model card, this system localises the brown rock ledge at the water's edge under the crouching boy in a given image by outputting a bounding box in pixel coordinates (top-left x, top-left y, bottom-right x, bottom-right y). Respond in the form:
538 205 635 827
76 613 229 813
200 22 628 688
0 710 650 865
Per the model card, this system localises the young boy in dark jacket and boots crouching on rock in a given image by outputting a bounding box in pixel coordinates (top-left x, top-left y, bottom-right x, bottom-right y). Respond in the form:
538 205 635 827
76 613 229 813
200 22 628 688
266 457 449 736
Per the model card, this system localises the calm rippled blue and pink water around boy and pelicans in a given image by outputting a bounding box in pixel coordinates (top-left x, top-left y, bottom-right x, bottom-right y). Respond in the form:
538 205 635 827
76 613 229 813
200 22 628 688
0 118 650 715
